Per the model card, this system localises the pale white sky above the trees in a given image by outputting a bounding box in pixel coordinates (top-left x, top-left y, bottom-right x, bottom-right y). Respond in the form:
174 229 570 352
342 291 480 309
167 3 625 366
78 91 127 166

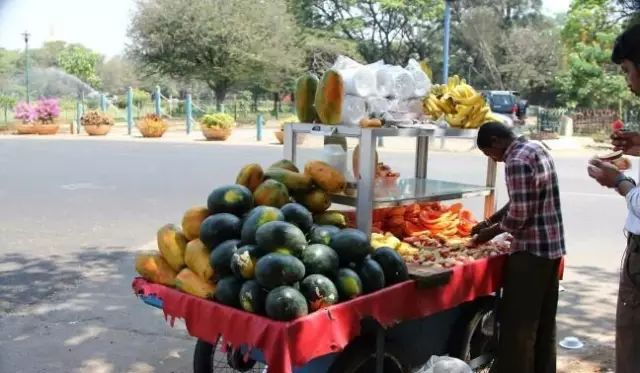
0 0 571 56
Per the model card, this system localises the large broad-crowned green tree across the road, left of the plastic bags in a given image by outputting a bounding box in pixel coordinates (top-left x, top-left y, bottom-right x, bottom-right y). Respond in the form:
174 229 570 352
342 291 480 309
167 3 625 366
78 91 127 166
128 0 302 109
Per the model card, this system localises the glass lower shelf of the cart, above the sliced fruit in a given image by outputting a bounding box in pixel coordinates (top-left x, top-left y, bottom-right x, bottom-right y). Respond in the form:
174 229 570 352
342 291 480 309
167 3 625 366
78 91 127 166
332 179 493 207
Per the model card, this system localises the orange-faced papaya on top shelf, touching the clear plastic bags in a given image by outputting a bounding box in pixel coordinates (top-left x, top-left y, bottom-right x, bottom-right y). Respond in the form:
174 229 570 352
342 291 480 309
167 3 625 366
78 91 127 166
314 70 344 124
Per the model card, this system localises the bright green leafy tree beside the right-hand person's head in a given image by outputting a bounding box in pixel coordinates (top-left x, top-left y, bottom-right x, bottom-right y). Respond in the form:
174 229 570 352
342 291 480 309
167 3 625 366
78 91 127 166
557 0 632 108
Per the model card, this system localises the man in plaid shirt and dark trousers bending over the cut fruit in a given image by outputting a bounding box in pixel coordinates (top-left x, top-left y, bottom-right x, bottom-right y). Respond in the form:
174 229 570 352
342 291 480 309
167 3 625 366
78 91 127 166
472 123 566 373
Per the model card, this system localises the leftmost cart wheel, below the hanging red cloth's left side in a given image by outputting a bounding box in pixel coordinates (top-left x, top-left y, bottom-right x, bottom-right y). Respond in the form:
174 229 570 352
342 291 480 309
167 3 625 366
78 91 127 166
193 339 266 373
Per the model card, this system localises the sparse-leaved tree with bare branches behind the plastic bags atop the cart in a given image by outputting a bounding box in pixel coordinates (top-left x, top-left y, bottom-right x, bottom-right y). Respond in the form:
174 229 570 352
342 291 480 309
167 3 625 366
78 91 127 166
290 0 444 64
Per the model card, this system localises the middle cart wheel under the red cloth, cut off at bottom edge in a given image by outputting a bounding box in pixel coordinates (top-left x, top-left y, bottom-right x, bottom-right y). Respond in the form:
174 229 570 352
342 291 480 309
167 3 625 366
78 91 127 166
329 339 407 373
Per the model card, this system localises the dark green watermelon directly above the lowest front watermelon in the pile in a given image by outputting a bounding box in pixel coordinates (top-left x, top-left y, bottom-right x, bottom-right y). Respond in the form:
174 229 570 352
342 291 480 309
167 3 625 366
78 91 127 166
255 253 305 289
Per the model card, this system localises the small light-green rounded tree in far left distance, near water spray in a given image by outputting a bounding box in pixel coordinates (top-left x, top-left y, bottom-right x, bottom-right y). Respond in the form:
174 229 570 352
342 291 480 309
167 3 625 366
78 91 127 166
58 44 101 88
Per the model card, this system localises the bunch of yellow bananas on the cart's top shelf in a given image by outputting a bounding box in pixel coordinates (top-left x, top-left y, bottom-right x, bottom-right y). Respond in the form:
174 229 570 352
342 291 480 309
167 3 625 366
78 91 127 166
423 75 495 129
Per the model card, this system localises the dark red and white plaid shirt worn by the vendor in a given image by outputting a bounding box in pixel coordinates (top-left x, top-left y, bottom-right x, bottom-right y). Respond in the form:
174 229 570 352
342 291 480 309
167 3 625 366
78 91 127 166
500 139 566 259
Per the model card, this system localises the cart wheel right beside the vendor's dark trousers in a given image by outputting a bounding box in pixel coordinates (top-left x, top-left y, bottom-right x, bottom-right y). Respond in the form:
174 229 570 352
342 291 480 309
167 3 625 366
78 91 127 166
460 306 498 373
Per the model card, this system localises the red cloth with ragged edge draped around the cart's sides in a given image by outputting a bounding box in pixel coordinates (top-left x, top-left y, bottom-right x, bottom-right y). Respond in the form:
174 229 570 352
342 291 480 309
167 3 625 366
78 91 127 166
132 256 506 373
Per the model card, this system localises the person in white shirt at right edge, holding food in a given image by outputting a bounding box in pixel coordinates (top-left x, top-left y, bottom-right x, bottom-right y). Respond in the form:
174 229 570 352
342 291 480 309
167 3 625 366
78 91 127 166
587 25 640 373
